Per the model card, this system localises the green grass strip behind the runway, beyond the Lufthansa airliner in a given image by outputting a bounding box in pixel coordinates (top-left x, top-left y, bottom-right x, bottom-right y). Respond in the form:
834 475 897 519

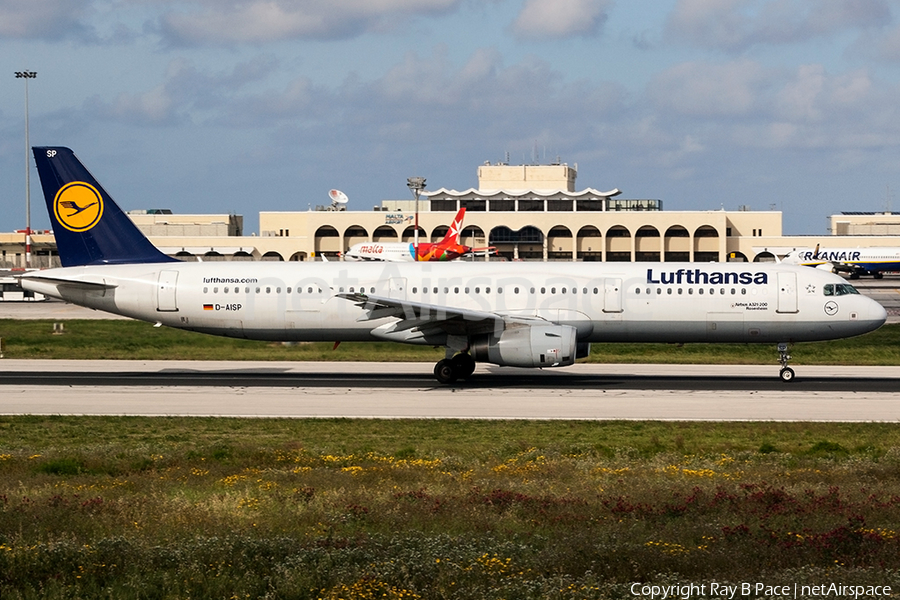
0 319 900 365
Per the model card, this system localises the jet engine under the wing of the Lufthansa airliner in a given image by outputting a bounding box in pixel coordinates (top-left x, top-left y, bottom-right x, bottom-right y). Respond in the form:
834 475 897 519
469 325 583 367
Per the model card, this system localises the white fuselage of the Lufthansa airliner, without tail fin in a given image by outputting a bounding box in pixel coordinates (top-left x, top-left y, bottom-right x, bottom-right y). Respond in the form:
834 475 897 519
22 262 886 344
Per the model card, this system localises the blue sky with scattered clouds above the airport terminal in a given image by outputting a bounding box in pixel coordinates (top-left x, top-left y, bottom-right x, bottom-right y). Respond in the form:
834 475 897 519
0 0 900 234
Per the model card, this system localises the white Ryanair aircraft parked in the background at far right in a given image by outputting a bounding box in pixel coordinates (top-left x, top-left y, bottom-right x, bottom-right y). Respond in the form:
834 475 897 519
781 245 900 279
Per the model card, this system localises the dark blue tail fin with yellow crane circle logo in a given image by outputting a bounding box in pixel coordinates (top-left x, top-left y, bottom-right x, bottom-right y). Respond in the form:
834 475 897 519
32 146 175 267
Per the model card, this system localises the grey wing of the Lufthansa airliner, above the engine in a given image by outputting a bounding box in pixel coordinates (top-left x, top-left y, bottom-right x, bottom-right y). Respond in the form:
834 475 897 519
337 293 546 337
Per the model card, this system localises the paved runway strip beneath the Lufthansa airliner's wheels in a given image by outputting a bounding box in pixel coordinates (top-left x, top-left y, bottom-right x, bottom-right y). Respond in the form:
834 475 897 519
0 360 900 422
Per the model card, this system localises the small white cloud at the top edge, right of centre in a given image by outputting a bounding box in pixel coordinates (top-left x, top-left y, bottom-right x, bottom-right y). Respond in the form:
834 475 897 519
512 0 612 39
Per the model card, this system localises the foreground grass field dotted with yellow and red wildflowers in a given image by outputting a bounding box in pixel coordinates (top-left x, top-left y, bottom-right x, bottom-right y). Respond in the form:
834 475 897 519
0 417 900 600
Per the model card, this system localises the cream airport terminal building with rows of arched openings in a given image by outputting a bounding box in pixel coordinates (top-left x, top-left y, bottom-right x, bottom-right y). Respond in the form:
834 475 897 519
0 163 900 268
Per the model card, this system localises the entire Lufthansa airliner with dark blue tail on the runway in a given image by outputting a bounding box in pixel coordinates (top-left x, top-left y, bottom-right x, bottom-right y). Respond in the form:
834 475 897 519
21 147 886 383
